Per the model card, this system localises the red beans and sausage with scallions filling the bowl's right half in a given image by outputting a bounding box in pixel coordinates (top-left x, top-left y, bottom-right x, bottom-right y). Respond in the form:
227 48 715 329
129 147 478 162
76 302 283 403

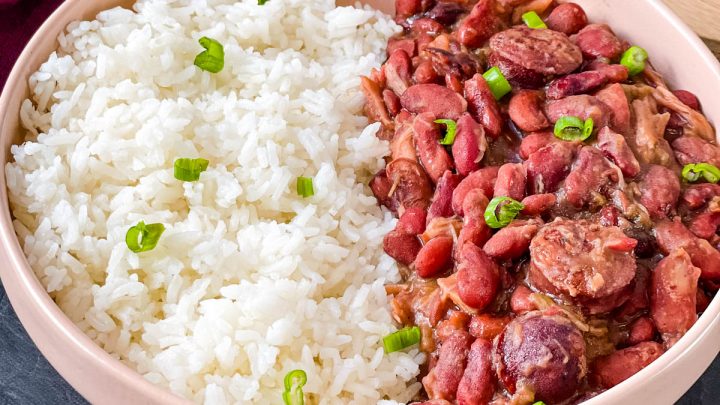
363 0 720 404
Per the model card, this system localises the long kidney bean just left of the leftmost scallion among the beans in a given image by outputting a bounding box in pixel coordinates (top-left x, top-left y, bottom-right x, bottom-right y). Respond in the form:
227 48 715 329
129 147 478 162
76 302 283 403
413 113 454 183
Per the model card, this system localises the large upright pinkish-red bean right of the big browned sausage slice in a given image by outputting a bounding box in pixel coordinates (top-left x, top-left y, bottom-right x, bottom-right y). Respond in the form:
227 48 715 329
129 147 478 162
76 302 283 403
650 249 701 347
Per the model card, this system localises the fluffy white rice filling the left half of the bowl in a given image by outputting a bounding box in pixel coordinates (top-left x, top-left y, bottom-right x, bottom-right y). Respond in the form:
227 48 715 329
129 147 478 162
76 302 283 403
6 0 423 404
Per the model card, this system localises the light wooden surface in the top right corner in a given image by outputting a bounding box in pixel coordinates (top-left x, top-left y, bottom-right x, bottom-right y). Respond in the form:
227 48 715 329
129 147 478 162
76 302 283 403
663 0 720 58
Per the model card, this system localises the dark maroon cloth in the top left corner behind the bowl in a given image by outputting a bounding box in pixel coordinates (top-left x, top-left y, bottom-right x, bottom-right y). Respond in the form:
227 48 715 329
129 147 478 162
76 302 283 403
0 0 62 88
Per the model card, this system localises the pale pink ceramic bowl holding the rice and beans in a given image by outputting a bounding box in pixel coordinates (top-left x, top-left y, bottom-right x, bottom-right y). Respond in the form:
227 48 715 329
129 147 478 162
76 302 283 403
0 0 720 404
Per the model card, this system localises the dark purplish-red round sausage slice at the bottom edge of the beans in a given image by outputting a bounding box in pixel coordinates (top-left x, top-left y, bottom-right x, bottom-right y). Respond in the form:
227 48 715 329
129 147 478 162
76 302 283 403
494 311 587 403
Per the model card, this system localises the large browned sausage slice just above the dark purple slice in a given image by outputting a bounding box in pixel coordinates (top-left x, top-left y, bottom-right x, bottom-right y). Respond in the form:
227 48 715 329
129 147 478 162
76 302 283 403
530 219 637 298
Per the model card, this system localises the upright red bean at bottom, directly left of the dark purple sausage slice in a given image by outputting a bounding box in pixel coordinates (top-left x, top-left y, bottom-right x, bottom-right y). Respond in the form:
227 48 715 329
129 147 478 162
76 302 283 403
457 339 496 405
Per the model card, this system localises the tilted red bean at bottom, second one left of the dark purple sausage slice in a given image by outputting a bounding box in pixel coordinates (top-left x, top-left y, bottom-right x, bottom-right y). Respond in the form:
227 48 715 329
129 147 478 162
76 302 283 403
422 331 472 400
